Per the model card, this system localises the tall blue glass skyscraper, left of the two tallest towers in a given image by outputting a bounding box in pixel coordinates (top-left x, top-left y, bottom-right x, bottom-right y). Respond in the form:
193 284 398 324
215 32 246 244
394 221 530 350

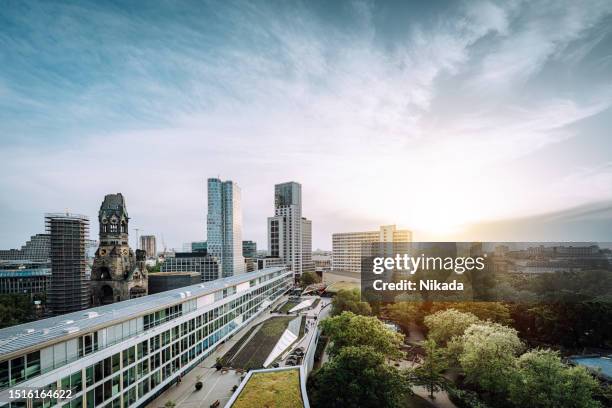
206 178 246 277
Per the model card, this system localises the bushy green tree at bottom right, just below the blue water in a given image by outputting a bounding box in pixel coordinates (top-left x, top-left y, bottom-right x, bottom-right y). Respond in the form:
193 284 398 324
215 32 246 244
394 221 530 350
509 349 601 408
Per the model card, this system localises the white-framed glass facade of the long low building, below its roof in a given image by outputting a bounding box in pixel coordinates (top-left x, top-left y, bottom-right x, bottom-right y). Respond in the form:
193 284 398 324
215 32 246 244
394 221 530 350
0 270 292 408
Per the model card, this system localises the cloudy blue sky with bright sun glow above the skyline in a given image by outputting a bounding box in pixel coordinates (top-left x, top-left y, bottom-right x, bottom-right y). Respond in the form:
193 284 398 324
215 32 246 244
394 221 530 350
0 0 612 249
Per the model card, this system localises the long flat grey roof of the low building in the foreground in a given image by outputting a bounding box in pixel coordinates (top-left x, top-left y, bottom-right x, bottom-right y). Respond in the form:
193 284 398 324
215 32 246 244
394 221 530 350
0 267 285 359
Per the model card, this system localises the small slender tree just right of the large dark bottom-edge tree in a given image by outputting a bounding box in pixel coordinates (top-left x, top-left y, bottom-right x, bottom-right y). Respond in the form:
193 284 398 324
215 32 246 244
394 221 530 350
411 340 448 399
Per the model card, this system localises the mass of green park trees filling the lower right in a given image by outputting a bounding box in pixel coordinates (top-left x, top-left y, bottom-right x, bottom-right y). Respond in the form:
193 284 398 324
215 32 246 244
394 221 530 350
309 291 612 408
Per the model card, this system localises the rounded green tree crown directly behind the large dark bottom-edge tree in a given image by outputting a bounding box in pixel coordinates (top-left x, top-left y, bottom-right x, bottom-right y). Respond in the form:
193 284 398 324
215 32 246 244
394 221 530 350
321 312 404 358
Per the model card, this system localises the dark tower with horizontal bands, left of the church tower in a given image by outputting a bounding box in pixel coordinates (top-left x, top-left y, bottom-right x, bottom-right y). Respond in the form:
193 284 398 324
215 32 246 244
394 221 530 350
45 213 89 314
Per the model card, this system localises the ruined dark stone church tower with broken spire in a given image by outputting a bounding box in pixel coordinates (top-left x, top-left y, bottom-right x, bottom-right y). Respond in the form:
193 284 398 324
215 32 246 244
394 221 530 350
91 193 148 306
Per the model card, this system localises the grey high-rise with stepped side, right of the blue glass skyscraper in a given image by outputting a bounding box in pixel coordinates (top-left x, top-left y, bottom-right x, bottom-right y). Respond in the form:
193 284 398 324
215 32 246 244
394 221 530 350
268 181 303 280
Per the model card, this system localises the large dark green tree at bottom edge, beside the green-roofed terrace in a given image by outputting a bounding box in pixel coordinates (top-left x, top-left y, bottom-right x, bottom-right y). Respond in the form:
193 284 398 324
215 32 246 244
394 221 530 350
308 346 411 408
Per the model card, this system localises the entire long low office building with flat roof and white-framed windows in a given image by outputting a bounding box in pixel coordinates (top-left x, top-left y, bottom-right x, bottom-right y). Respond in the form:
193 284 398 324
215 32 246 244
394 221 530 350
0 268 293 408
